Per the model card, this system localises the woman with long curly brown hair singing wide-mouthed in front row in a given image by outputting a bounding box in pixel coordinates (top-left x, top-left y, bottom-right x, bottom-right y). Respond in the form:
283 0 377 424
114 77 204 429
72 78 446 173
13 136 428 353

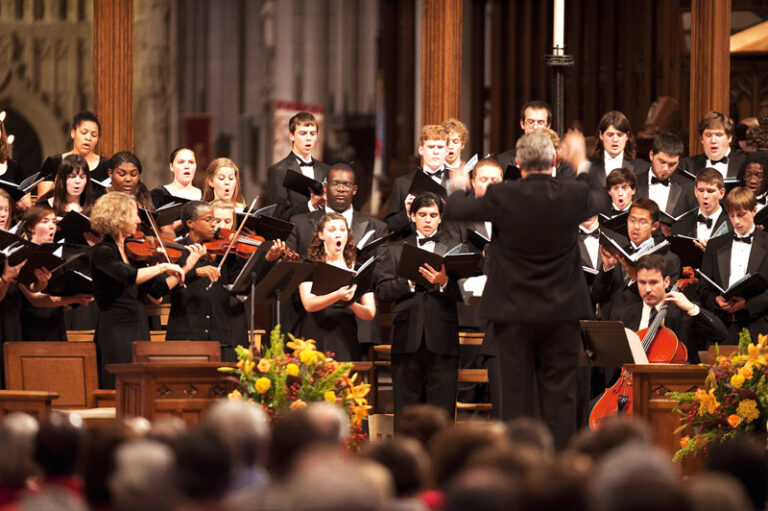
299 213 376 361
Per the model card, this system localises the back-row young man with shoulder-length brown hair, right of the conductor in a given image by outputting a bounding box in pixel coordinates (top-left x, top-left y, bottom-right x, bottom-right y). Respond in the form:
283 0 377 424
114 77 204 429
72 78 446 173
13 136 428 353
589 110 648 184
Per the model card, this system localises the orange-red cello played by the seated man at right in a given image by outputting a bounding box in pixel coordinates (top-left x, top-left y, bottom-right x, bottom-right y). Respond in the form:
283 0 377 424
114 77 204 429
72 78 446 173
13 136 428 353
589 266 698 431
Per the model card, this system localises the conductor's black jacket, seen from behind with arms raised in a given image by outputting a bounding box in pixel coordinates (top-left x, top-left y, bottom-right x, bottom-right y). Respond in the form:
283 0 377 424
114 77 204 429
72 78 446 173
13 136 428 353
445 173 610 322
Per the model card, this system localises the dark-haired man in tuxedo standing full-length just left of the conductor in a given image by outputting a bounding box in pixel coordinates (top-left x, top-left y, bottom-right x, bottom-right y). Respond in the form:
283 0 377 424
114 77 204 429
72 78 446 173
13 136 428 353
376 192 461 420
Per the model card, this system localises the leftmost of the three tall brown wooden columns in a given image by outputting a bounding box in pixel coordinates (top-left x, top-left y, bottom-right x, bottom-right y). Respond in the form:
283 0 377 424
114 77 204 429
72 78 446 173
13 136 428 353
93 0 134 158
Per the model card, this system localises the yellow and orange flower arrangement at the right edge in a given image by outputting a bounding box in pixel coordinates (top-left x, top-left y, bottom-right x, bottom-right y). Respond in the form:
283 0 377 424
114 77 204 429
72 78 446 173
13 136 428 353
667 330 768 461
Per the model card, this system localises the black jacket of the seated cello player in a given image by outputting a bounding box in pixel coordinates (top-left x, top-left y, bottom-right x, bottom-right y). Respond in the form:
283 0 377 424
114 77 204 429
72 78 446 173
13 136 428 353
608 301 728 364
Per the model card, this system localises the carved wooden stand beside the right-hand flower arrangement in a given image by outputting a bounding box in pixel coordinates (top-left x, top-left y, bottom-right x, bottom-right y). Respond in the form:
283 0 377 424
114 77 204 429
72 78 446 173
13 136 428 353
624 364 707 474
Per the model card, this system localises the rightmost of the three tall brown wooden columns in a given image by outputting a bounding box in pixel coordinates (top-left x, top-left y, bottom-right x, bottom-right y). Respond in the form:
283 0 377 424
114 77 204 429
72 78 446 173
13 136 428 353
688 0 731 154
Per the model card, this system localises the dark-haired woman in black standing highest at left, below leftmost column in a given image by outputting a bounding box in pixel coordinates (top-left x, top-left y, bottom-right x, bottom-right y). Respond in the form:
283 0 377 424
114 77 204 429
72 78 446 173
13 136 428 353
37 112 108 197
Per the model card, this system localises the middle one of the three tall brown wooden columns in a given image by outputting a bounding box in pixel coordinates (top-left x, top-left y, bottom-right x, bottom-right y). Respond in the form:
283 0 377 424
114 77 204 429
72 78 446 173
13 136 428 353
421 0 462 124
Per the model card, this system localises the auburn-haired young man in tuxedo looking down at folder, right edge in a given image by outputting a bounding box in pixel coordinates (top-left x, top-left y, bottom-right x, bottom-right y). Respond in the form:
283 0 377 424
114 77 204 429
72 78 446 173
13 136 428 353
699 186 768 344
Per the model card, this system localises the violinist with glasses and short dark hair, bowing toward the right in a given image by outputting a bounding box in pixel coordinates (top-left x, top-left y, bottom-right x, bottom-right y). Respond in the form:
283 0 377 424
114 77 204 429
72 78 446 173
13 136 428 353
166 201 284 361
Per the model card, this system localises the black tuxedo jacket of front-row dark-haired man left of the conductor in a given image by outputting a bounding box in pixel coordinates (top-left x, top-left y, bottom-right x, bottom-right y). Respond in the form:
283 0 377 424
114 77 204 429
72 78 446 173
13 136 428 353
376 235 461 356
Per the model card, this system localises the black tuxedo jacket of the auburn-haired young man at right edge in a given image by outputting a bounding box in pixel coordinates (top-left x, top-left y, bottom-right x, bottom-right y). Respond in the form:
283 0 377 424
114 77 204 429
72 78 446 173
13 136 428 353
699 229 768 341
